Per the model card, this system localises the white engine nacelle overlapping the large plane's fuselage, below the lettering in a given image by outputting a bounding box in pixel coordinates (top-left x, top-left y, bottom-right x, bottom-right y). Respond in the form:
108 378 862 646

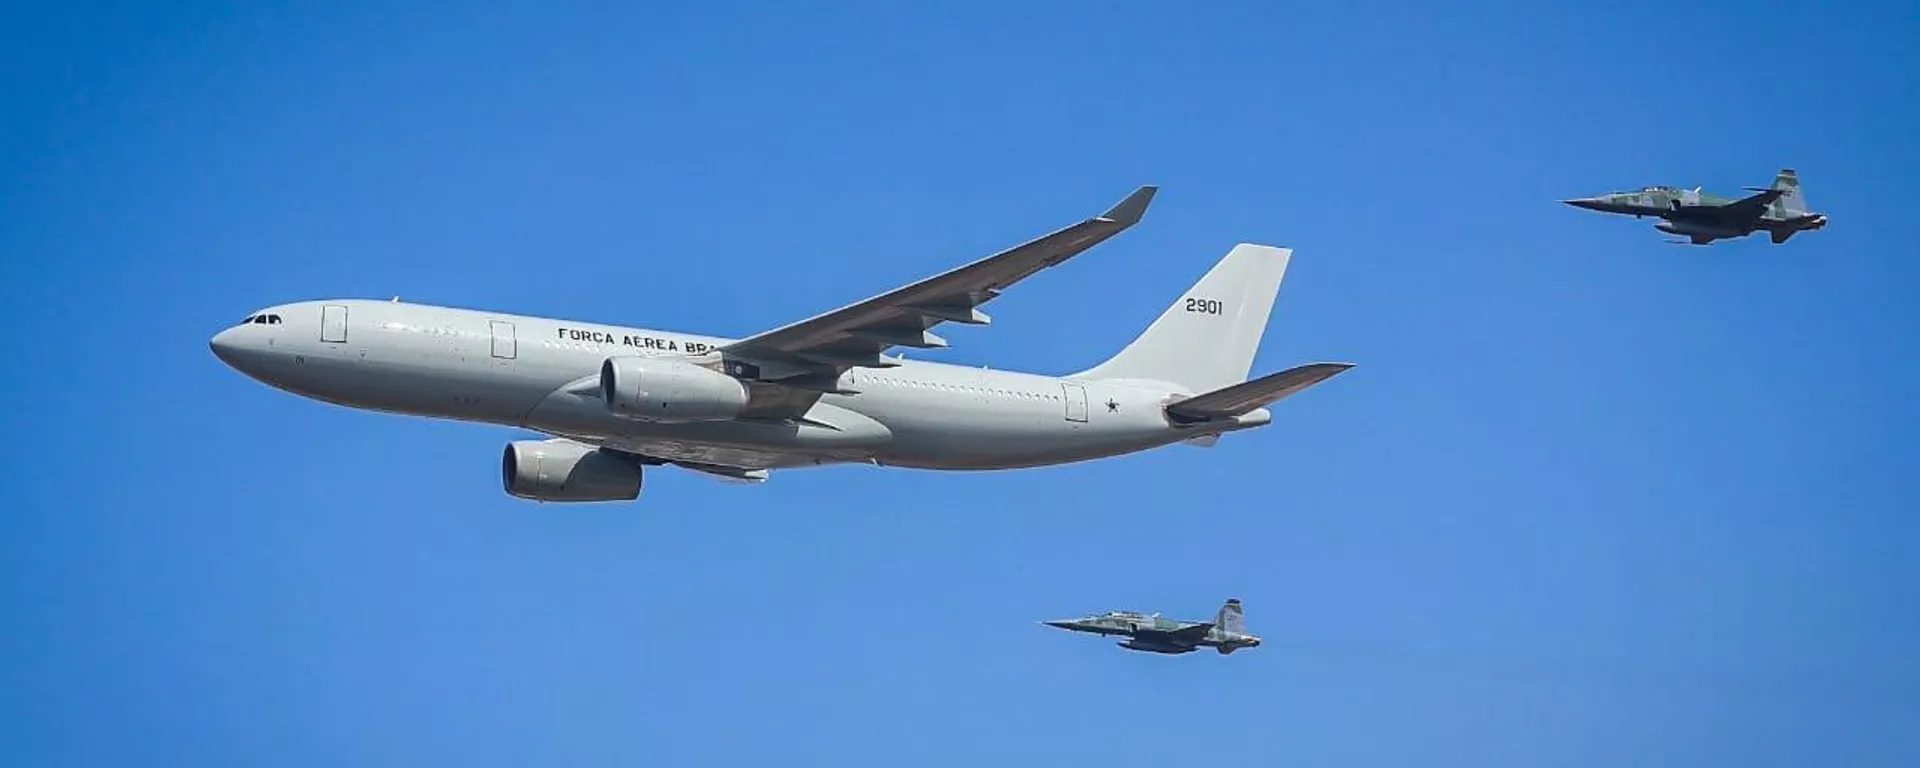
601 357 749 422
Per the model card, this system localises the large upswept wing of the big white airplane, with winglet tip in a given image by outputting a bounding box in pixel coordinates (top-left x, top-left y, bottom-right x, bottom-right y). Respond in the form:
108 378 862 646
720 186 1158 374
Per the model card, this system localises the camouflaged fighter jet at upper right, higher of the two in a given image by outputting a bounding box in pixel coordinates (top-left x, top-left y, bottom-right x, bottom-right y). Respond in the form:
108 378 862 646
1561 169 1826 246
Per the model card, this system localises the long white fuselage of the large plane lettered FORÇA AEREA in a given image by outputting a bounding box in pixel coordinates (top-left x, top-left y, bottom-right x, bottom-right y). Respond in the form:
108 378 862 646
211 300 1269 468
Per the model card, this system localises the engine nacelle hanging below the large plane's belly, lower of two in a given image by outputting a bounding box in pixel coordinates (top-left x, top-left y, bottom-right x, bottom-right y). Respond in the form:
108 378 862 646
499 440 639 501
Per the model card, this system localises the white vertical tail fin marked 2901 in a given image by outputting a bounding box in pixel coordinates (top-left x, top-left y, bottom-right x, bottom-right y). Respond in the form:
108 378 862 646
1073 242 1294 392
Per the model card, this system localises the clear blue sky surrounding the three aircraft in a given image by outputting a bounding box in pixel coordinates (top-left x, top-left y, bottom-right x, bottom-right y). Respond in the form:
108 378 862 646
0 2 1920 768
